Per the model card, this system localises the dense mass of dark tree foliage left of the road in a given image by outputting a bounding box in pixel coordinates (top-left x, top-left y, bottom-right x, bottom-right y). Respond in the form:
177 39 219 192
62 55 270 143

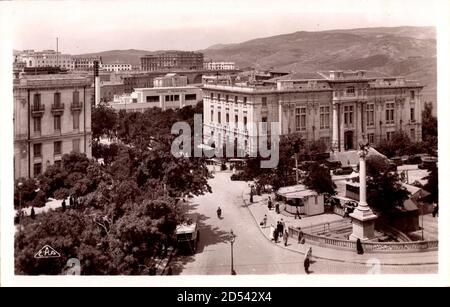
15 106 210 274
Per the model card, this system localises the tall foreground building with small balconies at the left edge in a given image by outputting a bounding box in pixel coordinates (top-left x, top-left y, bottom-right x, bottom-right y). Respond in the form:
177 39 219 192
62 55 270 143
13 74 93 178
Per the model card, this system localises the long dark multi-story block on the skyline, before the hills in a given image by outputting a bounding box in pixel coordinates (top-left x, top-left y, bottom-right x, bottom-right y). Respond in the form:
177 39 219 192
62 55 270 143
141 51 203 71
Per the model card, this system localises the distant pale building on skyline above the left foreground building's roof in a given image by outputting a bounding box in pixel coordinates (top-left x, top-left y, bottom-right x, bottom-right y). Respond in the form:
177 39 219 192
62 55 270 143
17 50 74 70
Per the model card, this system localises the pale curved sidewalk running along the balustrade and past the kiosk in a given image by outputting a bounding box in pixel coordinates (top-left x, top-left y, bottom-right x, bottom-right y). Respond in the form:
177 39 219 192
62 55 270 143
242 188 438 265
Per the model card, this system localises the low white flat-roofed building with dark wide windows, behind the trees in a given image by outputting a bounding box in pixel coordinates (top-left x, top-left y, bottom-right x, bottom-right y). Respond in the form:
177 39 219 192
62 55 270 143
110 86 202 112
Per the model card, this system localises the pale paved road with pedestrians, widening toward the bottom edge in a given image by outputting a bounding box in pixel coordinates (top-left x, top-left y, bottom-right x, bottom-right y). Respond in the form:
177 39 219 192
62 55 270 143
172 173 437 275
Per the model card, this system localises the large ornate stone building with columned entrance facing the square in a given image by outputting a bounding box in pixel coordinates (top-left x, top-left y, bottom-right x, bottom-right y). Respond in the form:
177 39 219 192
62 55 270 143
203 71 423 152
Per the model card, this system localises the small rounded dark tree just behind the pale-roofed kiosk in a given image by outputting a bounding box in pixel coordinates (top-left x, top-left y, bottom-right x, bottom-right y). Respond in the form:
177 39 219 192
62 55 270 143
303 163 336 195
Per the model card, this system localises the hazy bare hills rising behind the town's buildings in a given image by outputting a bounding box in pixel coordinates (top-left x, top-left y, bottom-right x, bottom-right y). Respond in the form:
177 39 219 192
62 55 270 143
76 26 437 111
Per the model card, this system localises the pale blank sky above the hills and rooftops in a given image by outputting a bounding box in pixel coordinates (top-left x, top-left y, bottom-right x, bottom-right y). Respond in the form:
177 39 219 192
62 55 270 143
2 0 441 54
